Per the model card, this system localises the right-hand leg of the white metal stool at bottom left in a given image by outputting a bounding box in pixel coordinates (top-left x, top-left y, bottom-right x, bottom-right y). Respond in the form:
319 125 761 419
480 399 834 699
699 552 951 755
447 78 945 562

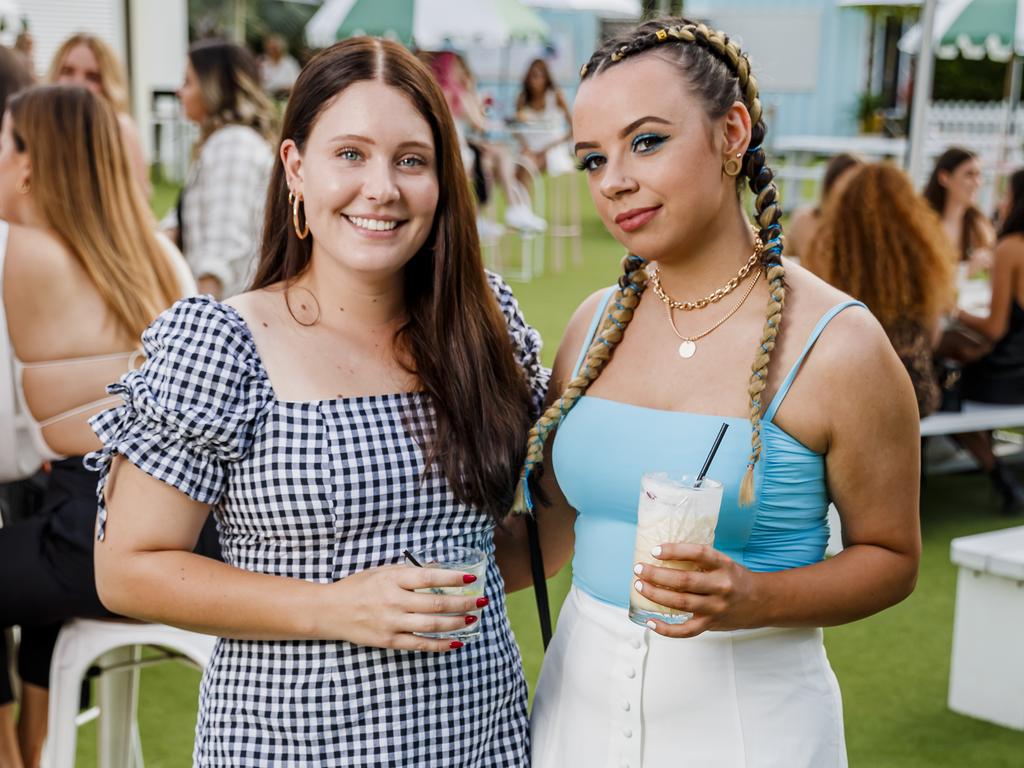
96 645 142 768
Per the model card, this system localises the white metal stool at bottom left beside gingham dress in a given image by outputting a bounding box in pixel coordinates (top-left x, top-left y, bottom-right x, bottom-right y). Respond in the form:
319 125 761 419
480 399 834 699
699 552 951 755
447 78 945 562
42 618 216 768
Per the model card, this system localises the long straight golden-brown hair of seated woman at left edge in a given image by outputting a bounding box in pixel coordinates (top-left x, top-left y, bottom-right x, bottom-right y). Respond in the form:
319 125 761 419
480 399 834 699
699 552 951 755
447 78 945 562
7 85 181 337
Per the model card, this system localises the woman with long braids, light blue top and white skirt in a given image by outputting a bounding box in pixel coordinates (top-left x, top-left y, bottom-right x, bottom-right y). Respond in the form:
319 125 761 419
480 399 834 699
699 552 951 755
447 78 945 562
493 20 920 768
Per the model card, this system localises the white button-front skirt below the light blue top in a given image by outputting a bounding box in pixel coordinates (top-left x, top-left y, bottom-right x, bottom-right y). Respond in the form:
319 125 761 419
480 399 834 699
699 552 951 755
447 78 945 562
530 587 847 768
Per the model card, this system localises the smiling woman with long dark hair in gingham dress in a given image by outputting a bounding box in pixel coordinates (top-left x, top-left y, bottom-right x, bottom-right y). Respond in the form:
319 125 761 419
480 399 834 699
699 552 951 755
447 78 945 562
93 38 547 768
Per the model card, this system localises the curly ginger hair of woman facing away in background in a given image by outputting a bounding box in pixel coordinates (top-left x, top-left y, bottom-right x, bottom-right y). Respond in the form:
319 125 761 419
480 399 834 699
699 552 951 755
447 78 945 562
807 163 953 330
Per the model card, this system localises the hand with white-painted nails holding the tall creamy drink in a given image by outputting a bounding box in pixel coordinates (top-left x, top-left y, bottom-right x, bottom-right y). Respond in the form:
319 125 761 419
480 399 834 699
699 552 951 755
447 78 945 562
633 544 757 637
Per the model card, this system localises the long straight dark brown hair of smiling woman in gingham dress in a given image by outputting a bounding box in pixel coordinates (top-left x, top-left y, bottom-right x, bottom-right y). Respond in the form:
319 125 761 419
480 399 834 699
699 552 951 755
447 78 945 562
252 37 530 518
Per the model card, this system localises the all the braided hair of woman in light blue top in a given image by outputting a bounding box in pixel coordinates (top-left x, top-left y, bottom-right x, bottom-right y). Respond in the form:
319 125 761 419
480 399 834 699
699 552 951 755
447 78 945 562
512 18 785 514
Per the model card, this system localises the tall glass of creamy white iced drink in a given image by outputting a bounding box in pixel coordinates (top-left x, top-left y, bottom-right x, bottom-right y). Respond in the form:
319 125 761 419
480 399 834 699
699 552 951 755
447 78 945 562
630 472 722 625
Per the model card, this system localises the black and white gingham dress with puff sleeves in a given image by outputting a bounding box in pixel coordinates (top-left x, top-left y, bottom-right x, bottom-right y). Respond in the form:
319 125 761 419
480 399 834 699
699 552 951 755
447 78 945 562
89 276 548 768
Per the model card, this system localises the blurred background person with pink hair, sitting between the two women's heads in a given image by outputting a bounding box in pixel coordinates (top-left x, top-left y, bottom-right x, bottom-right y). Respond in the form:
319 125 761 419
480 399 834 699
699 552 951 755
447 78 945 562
429 51 548 232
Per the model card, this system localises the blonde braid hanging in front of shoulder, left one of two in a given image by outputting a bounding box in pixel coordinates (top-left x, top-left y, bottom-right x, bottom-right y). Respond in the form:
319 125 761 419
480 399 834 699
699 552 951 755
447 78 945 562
512 254 647 514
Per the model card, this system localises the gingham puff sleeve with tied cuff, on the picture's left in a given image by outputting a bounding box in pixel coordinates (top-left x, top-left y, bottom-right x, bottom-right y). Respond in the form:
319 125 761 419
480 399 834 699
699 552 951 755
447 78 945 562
86 296 272 539
